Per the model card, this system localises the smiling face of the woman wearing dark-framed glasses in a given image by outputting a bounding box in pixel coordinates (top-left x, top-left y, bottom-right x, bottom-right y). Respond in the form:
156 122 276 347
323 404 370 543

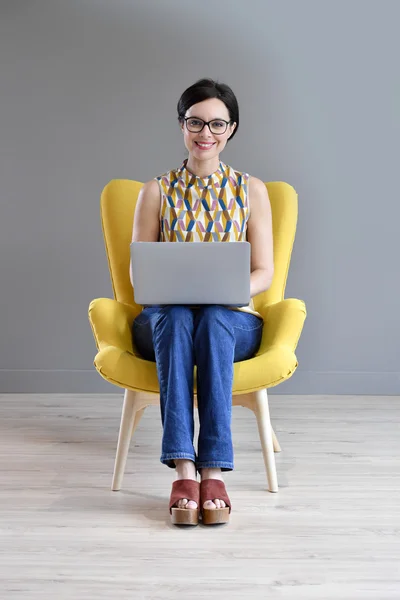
181 98 236 160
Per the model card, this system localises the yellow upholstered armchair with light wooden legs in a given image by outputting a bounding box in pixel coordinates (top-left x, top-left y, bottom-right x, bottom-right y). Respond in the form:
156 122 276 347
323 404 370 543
89 180 306 492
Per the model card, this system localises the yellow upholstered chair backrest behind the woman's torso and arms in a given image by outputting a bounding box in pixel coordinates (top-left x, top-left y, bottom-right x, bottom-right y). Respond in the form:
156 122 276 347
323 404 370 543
100 179 298 310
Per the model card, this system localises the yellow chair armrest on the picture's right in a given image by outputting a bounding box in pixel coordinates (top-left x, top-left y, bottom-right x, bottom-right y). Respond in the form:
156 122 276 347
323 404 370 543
257 298 307 355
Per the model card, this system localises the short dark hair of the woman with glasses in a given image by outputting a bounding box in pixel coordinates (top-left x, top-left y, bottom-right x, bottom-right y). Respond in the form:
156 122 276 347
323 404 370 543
177 79 239 141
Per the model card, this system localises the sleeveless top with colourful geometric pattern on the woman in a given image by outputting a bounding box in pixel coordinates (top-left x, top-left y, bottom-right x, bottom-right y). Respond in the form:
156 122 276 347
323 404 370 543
155 159 260 317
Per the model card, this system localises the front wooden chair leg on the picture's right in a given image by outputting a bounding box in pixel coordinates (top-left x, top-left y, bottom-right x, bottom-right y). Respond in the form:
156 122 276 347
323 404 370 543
253 390 278 492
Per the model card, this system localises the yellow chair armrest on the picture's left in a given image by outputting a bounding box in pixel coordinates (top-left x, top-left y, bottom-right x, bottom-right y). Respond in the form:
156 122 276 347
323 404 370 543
88 298 141 354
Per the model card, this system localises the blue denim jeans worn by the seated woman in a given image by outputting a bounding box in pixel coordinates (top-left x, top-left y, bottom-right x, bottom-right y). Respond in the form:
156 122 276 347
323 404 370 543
133 305 263 471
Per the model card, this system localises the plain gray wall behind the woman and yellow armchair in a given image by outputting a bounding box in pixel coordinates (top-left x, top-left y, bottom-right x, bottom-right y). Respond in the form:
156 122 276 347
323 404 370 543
0 0 400 394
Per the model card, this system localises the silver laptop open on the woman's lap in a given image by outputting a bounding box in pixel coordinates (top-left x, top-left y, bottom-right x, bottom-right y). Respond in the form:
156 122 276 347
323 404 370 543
131 242 250 306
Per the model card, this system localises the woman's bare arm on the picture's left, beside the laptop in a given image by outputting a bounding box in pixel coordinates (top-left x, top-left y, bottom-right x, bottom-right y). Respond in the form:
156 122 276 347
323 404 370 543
129 179 161 286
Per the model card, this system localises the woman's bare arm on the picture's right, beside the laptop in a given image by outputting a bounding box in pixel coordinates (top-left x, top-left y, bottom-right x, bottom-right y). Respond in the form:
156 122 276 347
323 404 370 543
247 177 274 297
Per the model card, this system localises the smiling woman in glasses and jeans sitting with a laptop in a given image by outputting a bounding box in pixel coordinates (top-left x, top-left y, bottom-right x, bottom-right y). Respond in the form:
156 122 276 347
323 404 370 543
131 79 273 524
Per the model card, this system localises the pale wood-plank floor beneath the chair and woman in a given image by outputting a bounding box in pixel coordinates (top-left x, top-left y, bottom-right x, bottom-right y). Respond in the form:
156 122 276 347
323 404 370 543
0 395 400 600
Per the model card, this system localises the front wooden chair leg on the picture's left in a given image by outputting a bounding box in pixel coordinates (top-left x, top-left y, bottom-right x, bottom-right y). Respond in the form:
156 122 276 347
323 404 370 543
111 390 144 492
